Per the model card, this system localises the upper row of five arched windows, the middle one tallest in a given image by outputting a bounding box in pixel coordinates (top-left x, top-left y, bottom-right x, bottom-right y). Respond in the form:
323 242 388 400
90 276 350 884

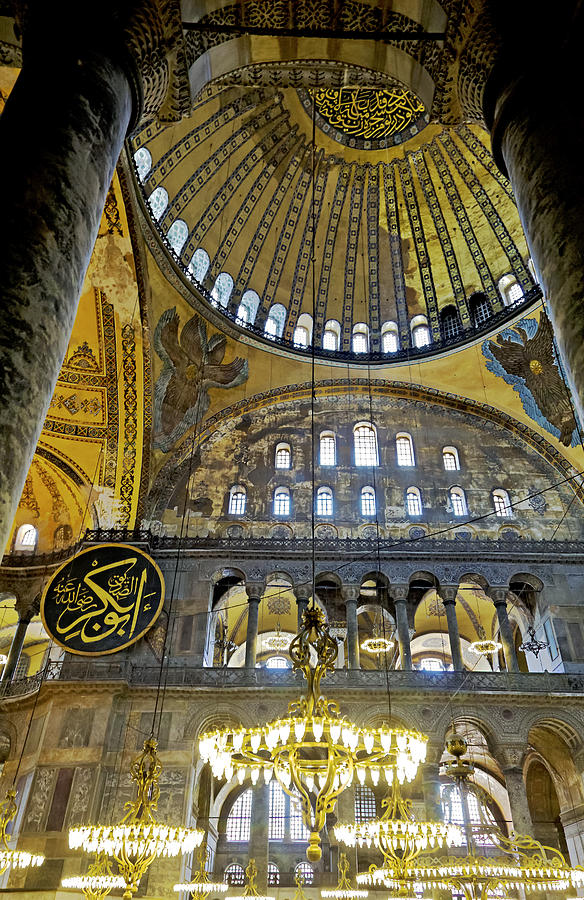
274 436 460 471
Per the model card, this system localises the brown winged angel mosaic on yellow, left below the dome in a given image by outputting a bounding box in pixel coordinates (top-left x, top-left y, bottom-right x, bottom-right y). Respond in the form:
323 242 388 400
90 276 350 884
153 307 248 453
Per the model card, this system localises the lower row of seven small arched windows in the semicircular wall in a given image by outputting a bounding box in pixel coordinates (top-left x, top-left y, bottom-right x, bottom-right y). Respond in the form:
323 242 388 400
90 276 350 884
228 484 512 518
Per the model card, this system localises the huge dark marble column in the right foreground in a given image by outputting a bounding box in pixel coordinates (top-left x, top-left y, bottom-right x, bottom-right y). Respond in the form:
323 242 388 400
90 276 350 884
484 16 584 426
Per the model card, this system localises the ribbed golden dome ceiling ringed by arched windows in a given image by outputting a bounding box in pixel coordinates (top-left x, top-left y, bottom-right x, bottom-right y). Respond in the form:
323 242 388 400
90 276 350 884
132 76 540 363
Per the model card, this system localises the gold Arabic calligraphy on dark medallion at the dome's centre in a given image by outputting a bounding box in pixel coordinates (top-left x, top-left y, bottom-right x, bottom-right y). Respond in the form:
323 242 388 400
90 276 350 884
314 88 424 140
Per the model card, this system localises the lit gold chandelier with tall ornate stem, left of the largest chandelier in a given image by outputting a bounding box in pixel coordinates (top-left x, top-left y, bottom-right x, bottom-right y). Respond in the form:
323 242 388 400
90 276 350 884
69 737 204 900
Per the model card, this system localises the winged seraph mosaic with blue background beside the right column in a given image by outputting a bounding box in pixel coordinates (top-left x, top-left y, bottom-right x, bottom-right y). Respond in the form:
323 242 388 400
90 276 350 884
482 312 578 447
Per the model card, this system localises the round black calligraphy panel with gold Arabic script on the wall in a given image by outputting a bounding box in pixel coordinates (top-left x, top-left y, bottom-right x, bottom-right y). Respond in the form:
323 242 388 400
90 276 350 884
41 544 164 656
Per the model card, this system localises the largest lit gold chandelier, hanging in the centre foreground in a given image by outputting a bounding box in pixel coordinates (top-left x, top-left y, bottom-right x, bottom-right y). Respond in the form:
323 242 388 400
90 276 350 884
199 606 427 862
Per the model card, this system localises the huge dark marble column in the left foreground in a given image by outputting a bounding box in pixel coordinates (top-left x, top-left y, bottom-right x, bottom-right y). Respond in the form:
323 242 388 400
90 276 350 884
0 3 135 549
